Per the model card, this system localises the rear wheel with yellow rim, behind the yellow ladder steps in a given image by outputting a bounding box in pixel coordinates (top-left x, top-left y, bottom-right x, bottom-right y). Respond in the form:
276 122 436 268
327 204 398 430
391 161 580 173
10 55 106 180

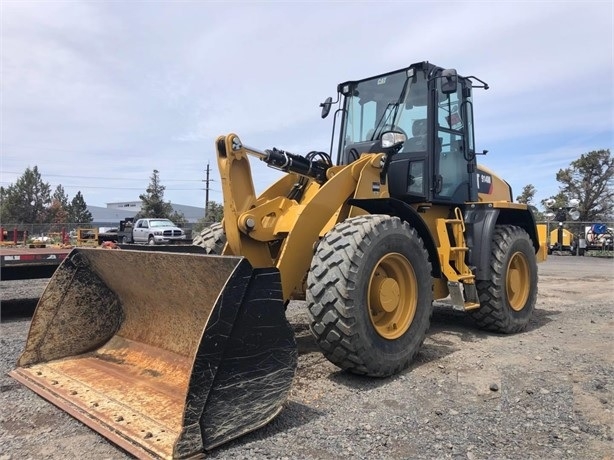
470 225 537 334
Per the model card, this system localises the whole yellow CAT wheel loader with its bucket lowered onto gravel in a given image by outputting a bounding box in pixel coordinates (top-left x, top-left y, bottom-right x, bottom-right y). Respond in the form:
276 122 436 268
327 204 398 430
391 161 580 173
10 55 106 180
11 62 546 458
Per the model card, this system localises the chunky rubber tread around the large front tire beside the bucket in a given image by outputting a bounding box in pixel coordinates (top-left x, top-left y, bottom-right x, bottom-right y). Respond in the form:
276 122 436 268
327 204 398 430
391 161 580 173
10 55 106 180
307 215 432 377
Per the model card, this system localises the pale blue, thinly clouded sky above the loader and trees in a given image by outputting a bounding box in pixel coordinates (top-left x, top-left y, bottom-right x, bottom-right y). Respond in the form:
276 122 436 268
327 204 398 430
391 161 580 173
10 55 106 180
0 0 614 206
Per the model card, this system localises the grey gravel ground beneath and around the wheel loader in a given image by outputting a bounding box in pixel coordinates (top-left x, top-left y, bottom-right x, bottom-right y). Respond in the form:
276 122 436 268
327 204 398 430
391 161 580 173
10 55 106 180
0 255 614 460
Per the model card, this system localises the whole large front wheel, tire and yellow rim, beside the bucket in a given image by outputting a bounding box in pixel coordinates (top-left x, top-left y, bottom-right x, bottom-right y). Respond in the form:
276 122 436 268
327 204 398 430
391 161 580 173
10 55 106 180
306 215 433 377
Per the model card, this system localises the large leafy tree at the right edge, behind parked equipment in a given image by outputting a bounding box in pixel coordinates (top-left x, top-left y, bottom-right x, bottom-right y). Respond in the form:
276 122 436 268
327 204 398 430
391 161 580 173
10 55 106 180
553 149 614 222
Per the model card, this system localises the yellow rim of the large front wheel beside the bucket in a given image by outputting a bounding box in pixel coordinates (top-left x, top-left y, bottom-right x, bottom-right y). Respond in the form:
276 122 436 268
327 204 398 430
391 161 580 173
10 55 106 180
367 253 418 340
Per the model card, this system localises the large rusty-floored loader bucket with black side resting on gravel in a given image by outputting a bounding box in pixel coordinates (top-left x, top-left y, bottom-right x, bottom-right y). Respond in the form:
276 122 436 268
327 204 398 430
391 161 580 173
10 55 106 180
10 248 297 458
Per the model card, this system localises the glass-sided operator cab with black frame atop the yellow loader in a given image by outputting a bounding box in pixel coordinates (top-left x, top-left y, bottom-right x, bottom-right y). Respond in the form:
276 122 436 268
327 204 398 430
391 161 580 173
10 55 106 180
330 62 487 203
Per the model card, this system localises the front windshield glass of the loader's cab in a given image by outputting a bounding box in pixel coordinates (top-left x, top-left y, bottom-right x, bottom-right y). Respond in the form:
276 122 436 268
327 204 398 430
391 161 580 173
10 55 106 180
343 70 428 148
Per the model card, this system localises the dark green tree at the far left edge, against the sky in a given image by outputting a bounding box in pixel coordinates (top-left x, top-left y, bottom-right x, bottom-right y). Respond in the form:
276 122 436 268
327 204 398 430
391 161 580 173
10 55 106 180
0 166 51 224
